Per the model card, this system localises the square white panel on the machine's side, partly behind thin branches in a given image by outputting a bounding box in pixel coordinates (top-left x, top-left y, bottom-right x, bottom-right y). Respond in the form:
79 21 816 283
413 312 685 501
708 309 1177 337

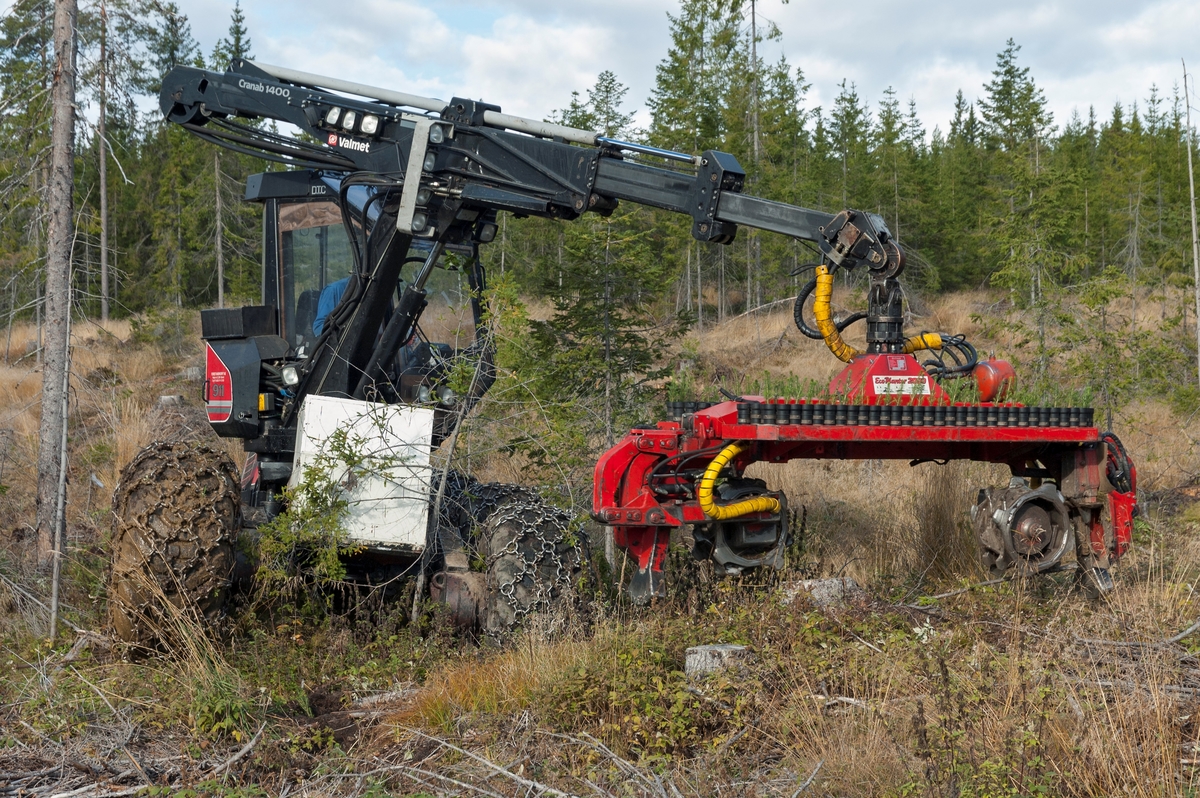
288 396 433 552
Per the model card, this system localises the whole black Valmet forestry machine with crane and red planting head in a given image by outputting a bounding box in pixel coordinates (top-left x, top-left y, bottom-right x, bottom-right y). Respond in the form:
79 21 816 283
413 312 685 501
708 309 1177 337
114 59 1136 643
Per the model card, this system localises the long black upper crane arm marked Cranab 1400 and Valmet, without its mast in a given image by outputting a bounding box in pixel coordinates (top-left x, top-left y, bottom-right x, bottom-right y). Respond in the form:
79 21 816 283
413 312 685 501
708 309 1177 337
161 59 835 242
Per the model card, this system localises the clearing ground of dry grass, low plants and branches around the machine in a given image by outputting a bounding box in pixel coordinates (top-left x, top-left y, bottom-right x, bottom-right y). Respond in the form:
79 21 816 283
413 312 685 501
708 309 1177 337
0 294 1200 798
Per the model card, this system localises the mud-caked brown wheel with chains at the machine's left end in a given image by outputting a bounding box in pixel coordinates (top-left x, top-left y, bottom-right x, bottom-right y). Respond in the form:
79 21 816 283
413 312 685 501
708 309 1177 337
108 442 240 647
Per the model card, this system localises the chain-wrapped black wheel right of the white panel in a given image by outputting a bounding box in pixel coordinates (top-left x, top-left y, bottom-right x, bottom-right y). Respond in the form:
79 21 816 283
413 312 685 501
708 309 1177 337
472 482 587 637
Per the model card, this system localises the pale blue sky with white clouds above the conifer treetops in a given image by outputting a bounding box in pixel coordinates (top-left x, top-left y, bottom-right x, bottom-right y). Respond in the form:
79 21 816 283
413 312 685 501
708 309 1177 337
166 0 1200 132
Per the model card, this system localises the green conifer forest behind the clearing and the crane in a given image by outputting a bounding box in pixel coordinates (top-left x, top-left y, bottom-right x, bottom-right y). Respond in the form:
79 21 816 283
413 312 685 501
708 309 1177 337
0 0 1195 410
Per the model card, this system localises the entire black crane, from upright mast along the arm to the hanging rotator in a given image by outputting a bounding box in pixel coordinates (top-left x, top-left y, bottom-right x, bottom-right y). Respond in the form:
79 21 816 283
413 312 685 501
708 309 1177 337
160 59 906 421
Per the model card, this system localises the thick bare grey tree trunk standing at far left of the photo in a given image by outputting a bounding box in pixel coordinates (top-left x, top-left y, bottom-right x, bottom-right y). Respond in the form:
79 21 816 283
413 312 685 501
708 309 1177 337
37 0 78 568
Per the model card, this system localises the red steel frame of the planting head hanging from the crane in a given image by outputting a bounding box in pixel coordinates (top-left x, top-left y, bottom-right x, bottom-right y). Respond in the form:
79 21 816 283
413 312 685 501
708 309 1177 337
593 355 1136 588
